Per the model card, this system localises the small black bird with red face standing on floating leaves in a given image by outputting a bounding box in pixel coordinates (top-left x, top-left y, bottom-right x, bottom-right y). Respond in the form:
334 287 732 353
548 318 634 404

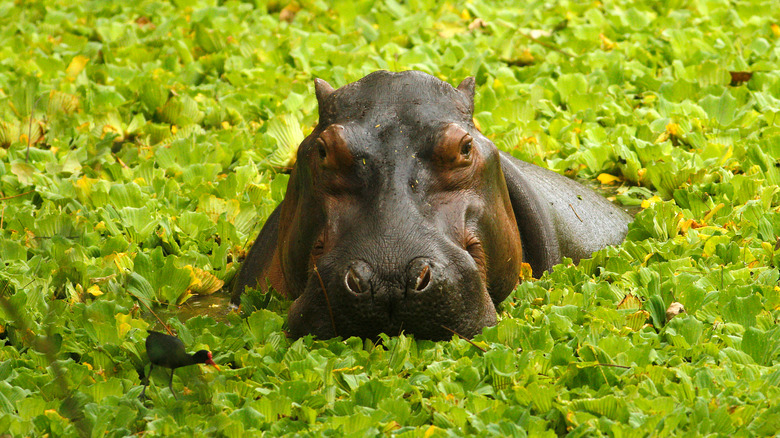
141 330 219 399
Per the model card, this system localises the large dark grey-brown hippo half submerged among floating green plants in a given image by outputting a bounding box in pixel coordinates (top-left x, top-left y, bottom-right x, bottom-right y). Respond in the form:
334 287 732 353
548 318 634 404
231 71 630 340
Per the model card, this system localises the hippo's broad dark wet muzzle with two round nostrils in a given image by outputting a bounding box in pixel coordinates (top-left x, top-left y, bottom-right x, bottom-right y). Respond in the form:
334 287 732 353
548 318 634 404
288 219 496 339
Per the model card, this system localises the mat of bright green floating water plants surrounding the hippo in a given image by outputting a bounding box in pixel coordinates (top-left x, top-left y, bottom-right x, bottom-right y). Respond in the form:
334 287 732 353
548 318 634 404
0 0 780 437
